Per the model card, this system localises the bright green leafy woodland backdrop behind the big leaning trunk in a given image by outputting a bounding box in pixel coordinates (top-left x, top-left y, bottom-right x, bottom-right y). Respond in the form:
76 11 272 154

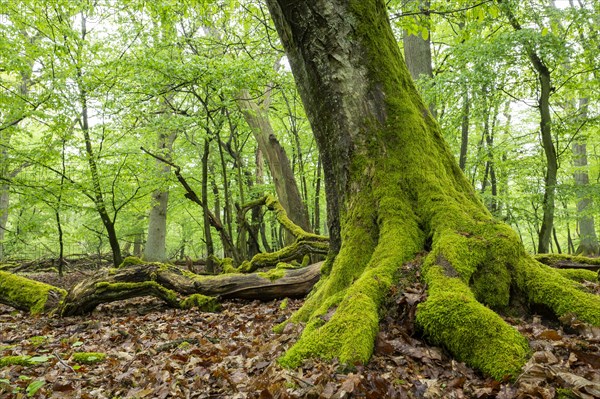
0 0 600 259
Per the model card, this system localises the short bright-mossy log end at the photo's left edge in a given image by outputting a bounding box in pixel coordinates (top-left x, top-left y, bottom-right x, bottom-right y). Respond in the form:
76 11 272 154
0 271 67 314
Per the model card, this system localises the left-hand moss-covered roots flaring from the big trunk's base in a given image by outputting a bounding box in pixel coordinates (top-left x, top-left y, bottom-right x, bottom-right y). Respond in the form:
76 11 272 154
280 188 422 367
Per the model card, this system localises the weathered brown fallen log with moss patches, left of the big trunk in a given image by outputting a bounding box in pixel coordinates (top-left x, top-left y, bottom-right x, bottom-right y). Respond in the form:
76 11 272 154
56 263 321 316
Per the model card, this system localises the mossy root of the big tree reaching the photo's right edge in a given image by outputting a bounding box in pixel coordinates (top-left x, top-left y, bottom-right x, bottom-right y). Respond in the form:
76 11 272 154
516 257 600 326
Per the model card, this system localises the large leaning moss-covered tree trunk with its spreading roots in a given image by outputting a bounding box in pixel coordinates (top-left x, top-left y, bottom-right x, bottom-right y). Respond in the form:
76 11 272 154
267 0 600 378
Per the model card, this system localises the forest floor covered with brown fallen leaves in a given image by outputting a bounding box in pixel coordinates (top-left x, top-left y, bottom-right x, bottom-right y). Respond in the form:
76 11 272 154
0 273 600 399
